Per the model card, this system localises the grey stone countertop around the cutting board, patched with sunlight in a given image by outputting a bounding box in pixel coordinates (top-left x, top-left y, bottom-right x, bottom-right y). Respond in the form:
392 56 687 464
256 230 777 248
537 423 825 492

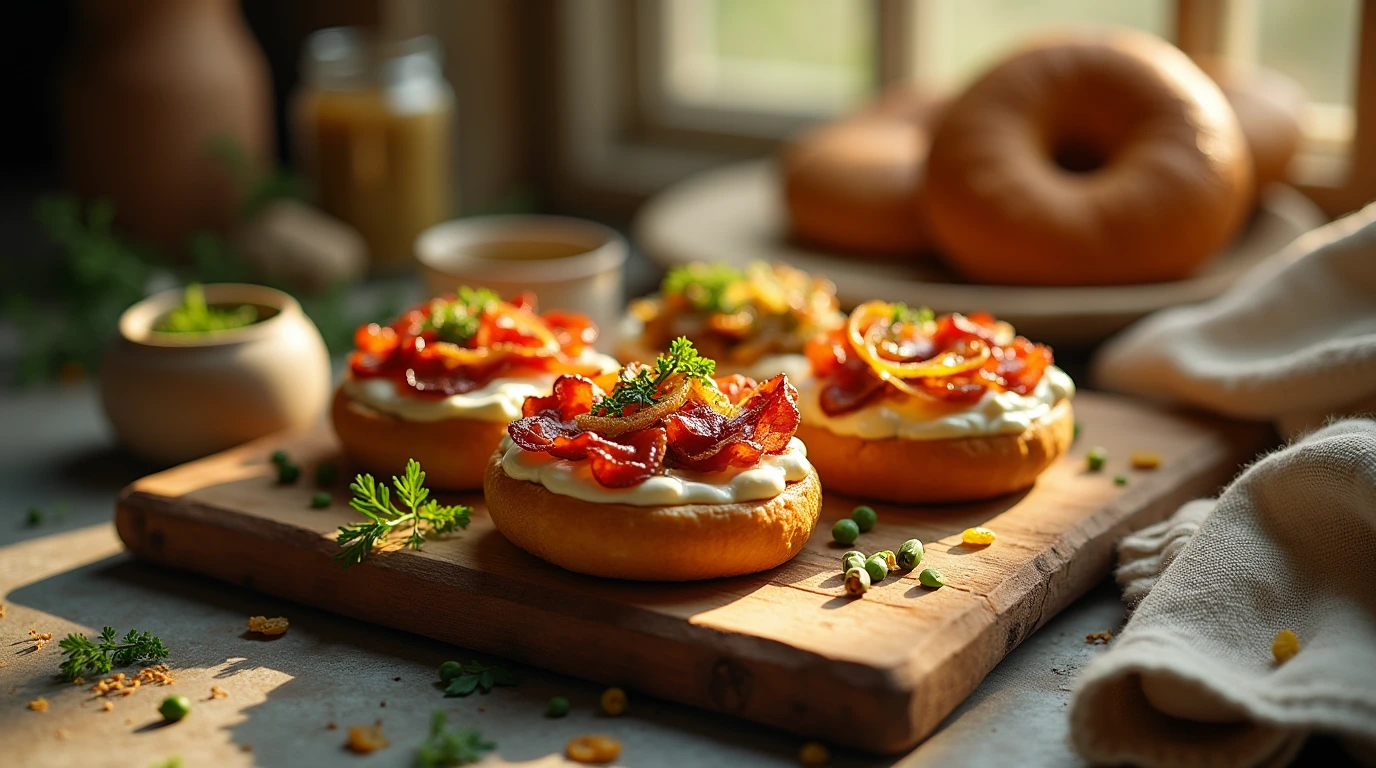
0 387 1124 768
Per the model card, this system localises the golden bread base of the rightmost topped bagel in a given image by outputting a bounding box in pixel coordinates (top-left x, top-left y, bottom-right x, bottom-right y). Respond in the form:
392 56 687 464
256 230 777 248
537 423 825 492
797 401 1075 504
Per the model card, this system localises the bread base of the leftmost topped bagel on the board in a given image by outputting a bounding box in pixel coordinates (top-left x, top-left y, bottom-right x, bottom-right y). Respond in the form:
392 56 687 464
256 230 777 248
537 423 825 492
330 388 506 490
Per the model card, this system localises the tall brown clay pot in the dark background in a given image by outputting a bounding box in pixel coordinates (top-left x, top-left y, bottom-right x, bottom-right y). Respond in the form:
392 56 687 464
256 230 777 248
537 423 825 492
62 0 272 248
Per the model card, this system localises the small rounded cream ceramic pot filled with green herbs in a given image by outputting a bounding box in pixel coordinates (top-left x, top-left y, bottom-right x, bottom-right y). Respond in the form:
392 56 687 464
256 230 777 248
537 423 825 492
100 284 330 464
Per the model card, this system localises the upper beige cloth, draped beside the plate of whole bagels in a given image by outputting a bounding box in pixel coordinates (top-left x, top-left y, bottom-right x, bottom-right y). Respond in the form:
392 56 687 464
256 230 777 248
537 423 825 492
1093 204 1376 435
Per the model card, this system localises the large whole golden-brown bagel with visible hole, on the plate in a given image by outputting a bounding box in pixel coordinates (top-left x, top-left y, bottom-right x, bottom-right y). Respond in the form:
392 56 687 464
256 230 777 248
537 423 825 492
922 29 1251 285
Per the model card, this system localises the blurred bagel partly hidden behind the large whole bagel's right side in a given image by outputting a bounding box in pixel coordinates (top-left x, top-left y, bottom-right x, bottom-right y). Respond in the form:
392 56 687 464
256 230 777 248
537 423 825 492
1196 56 1309 191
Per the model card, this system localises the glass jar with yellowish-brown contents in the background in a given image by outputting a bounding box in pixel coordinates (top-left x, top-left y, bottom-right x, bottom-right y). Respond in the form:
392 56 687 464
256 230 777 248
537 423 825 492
292 28 454 271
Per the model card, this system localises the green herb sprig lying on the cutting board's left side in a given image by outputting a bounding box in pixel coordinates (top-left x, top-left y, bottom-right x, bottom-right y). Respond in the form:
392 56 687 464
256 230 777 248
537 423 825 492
334 458 473 568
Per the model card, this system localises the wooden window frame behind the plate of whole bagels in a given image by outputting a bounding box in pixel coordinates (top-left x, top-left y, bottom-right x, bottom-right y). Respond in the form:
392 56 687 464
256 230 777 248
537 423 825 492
555 0 1376 215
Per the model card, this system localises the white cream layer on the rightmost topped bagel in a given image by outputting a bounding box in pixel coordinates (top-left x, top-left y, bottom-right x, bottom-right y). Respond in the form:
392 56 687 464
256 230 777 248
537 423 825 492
797 366 1075 440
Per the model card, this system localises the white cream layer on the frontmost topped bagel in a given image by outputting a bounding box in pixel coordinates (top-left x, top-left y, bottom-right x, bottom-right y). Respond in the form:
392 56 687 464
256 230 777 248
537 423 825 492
501 436 812 506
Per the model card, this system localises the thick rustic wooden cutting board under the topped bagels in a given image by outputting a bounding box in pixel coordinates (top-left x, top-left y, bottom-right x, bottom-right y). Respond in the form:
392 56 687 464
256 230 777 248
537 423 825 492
116 392 1270 753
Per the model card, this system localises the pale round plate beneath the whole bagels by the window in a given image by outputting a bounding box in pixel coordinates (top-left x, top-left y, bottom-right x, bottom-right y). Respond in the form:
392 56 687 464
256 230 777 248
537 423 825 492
634 161 1326 347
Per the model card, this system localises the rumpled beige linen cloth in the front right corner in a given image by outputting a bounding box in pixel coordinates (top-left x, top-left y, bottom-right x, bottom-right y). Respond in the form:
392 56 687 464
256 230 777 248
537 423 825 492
1071 418 1376 767
